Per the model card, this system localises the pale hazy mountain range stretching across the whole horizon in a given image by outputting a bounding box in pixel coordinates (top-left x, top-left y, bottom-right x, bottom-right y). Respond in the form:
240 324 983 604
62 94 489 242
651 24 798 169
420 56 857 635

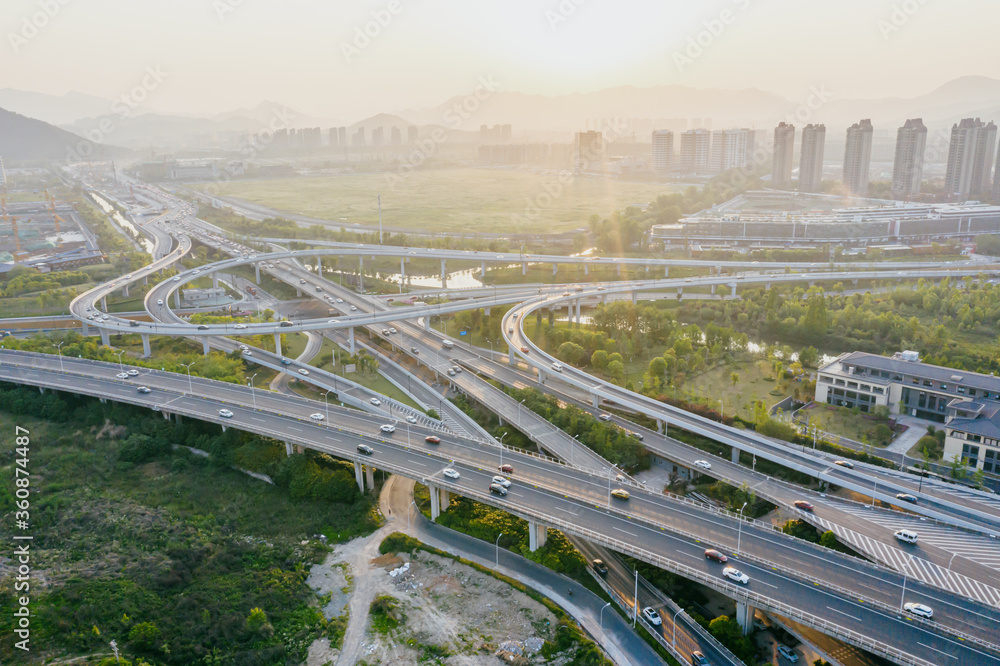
0 76 1000 154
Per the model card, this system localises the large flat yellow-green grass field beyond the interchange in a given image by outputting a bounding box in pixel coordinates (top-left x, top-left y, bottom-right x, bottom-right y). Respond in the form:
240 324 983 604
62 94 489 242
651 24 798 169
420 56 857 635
196 168 676 233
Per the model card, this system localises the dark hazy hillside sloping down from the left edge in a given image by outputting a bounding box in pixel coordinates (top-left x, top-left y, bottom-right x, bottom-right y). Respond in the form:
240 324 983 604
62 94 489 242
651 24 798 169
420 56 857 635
0 109 123 166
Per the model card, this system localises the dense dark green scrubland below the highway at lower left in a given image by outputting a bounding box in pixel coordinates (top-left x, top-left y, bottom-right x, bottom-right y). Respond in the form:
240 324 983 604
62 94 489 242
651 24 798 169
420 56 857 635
0 385 377 665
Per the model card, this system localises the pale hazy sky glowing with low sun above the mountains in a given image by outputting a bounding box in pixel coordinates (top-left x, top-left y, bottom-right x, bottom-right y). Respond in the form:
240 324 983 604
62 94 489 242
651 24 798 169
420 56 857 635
0 0 1000 120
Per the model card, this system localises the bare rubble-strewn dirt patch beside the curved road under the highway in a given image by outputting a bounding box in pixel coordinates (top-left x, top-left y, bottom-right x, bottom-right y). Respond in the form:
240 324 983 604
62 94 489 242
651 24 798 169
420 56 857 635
361 552 556 666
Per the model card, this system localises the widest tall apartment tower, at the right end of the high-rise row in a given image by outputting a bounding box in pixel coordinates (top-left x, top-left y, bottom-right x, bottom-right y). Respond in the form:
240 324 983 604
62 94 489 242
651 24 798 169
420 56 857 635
944 118 997 199
